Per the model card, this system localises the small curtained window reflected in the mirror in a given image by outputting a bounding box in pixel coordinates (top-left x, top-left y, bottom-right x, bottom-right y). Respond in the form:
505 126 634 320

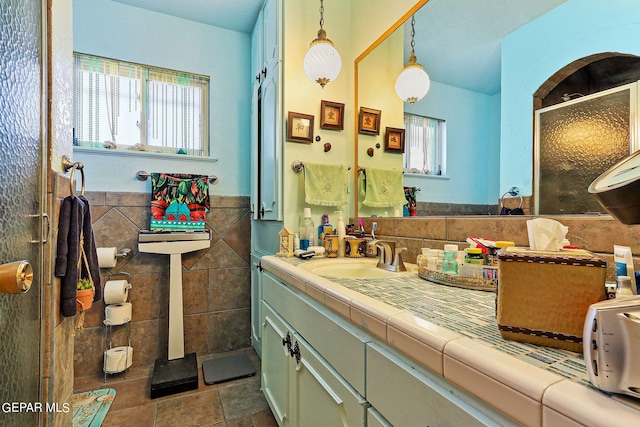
404 114 446 175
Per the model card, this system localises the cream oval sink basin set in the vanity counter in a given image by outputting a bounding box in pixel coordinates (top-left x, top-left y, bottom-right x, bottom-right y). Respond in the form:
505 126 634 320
299 258 417 279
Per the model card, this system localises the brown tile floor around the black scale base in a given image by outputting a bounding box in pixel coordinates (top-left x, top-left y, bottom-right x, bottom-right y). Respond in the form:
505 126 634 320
74 349 277 427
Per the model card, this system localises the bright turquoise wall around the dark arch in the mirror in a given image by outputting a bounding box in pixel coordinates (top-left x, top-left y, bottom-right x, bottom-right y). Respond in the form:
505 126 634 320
500 0 640 194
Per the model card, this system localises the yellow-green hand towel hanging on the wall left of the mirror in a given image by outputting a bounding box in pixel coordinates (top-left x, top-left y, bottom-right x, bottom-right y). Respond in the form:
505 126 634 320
304 162 349 206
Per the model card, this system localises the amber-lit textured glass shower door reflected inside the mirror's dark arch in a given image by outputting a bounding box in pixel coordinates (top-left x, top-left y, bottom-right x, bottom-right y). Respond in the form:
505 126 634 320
535 83 638 215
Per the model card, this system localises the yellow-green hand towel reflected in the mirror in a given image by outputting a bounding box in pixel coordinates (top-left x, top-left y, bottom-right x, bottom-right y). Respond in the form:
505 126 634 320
362 167 407 208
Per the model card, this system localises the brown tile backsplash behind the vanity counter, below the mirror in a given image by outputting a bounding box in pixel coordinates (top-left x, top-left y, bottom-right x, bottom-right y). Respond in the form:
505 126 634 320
358 215 640 281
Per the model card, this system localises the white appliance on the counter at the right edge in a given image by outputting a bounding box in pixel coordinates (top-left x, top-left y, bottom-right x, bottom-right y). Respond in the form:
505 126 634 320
583 295 640 397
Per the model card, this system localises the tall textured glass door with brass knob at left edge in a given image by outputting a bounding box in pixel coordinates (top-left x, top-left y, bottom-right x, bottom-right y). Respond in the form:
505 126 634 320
0 0 46 427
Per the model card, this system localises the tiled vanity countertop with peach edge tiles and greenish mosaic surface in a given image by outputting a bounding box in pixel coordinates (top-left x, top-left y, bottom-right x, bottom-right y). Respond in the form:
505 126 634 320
261 256 640 426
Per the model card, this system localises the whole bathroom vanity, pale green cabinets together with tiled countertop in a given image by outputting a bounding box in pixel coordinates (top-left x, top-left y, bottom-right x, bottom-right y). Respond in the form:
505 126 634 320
260 256 640 426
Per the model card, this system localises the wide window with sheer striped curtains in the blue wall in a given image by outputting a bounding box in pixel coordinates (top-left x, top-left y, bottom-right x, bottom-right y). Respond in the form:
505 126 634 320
74 53 209 156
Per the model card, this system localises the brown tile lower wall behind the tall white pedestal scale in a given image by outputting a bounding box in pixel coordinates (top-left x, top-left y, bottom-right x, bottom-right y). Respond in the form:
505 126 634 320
74 188 251 380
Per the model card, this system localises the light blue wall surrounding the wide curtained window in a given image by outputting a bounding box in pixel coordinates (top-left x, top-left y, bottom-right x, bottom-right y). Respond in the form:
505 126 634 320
73 0 250 196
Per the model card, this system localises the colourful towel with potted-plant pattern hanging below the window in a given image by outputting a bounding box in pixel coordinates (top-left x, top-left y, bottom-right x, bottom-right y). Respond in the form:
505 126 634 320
149 172 209 230
